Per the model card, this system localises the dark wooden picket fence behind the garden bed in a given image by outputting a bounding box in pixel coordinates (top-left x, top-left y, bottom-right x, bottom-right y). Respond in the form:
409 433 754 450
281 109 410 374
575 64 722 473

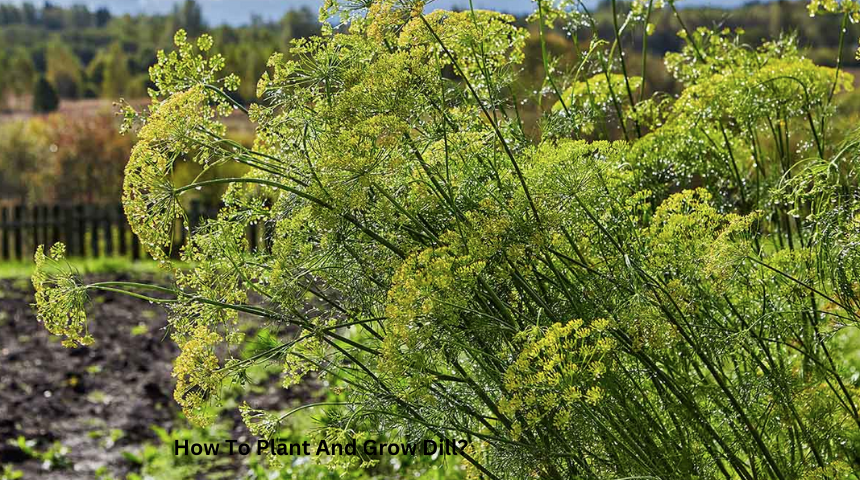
0 202 266 261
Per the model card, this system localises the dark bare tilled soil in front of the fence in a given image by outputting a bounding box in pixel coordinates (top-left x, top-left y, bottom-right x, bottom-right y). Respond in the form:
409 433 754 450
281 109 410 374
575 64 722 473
0 276 308 480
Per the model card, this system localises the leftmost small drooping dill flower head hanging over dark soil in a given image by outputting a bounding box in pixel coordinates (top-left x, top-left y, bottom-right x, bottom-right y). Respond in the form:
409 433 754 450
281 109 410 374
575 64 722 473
32 243 93 347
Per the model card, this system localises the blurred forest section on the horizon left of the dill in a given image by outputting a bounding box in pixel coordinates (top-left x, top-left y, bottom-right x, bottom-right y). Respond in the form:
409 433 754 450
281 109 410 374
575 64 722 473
0 0 319 105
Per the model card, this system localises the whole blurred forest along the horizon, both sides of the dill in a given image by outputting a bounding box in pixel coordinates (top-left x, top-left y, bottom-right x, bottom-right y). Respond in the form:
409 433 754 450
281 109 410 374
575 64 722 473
0 0 857 109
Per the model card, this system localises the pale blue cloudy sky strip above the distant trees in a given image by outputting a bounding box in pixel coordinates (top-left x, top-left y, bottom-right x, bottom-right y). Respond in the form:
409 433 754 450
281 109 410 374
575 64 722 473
0 0 772 26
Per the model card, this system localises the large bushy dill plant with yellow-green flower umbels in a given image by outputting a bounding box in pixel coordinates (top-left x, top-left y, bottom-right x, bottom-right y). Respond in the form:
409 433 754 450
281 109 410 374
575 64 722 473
33 0 860 480
